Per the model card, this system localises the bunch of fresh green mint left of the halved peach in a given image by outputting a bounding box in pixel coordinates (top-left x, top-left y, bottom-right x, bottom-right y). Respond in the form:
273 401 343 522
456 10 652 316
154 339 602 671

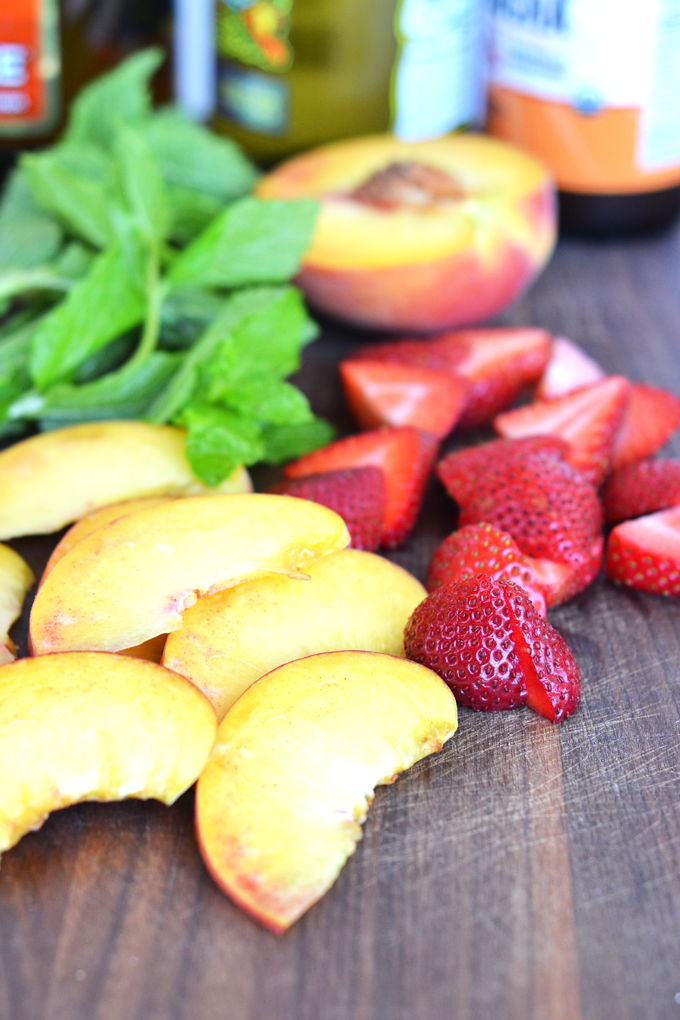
0 50 332 486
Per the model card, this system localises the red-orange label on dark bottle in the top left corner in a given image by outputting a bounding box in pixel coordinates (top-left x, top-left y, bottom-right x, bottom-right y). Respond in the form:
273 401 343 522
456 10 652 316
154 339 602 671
0 0 61 139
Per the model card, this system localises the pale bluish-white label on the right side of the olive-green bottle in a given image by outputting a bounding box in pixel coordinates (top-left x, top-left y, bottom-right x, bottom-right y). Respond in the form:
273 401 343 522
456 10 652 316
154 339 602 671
391 0 483 142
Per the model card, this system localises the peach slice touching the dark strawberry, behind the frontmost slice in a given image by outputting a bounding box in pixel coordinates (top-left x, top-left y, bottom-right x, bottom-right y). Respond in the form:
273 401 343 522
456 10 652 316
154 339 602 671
163 549 427 719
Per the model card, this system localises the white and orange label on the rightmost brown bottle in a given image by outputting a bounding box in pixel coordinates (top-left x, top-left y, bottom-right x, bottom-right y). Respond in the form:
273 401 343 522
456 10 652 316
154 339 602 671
488 0 680 194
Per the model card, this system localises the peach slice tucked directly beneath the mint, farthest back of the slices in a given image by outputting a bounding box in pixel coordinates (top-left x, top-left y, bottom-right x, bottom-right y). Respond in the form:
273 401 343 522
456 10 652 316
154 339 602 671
0 421 252 539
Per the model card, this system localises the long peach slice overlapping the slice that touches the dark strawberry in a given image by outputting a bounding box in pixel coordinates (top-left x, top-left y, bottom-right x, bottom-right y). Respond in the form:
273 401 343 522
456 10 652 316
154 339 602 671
31 493 350 655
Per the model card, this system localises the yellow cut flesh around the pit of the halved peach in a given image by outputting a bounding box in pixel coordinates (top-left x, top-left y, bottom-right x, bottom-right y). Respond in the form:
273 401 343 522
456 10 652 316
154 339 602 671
257 135 555 270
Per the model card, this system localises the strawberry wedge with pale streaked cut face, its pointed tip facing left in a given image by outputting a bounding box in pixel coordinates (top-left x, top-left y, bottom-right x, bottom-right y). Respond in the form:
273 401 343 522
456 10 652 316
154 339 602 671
493 375 630 486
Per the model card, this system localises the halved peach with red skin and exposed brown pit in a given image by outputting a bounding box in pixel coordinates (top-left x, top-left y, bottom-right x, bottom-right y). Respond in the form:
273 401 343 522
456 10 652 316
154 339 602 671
256 134 556 332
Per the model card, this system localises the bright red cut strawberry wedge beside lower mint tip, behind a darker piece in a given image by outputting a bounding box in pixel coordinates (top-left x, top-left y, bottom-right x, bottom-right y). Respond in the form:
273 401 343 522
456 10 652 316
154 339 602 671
284 427 437 549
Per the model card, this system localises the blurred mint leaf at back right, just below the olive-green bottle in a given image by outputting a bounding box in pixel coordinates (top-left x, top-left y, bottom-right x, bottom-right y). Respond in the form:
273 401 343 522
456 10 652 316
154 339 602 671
141 107 257 205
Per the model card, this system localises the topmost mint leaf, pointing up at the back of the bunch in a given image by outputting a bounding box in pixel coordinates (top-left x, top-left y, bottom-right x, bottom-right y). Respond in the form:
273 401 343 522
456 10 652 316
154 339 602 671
65 48 164 146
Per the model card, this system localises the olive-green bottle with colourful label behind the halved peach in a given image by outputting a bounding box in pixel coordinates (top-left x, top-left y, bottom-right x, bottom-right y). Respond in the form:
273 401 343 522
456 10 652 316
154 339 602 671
215 0 483 161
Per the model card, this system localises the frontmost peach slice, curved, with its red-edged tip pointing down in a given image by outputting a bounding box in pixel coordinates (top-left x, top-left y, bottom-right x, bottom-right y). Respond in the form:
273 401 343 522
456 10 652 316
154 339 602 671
196 652 457 932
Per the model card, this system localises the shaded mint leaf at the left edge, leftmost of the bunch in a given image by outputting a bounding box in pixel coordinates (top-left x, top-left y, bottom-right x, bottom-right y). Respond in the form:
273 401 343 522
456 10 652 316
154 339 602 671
0 169 62 269
